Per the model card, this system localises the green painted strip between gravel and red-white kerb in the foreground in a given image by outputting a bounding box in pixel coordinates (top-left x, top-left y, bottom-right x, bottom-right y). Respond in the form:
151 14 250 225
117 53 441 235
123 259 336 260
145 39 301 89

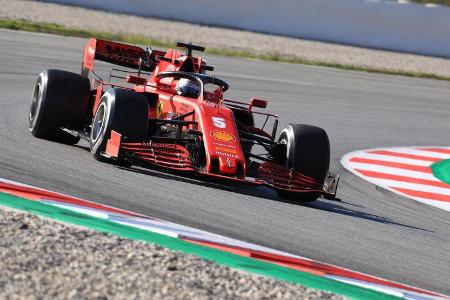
0 192 403 299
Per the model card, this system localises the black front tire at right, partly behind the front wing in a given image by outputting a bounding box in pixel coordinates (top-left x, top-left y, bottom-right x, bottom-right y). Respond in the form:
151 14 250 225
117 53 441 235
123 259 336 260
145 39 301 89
277 124 330 202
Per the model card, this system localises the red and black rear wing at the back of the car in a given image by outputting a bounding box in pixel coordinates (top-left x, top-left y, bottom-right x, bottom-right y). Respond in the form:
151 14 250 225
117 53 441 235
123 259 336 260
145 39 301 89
81 38 166 77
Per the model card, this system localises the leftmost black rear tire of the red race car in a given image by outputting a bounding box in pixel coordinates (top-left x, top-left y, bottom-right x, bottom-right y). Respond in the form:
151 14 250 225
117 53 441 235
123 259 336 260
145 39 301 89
28 69 90 144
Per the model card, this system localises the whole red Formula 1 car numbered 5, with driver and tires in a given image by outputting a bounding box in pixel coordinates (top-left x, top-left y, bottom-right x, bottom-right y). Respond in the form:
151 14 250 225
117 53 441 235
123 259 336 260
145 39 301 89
29 39 339 202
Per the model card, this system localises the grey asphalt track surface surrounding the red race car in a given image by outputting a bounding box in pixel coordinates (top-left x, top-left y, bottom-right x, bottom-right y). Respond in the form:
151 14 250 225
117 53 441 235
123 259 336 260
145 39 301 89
0 30 450 294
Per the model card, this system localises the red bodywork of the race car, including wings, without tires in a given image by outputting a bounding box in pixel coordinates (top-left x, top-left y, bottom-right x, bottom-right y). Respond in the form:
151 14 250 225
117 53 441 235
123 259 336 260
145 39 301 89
82 39 334 197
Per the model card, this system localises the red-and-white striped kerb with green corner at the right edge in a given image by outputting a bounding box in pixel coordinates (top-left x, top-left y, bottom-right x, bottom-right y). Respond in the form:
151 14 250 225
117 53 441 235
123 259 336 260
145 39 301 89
341 147 450 211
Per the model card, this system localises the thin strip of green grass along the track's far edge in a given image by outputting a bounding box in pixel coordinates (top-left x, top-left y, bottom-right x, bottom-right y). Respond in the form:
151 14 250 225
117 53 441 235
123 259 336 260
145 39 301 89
0 18 450 81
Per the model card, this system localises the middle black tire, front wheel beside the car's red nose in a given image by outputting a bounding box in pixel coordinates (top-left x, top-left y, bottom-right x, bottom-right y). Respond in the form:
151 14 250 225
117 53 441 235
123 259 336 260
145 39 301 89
90 88 148 163
